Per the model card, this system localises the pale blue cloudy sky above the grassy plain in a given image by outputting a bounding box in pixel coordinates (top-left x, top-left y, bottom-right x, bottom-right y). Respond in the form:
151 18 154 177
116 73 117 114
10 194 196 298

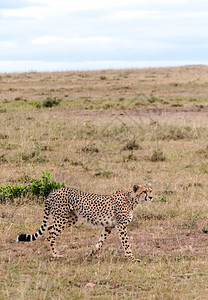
0 0 208 72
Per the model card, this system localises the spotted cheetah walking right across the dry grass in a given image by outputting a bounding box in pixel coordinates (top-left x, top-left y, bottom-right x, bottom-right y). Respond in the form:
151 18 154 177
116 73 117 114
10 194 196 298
17 185 153 261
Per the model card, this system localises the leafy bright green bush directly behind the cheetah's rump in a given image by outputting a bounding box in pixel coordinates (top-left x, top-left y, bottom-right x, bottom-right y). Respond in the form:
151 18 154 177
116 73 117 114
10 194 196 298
0 172 65 203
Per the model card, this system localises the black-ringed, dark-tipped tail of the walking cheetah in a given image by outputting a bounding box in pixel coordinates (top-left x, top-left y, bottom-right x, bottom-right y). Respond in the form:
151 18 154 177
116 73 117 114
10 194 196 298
17 200 50 242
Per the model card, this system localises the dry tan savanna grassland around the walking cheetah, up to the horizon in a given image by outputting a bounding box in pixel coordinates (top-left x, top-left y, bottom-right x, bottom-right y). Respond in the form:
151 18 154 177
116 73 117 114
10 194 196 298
0 66 208 300
